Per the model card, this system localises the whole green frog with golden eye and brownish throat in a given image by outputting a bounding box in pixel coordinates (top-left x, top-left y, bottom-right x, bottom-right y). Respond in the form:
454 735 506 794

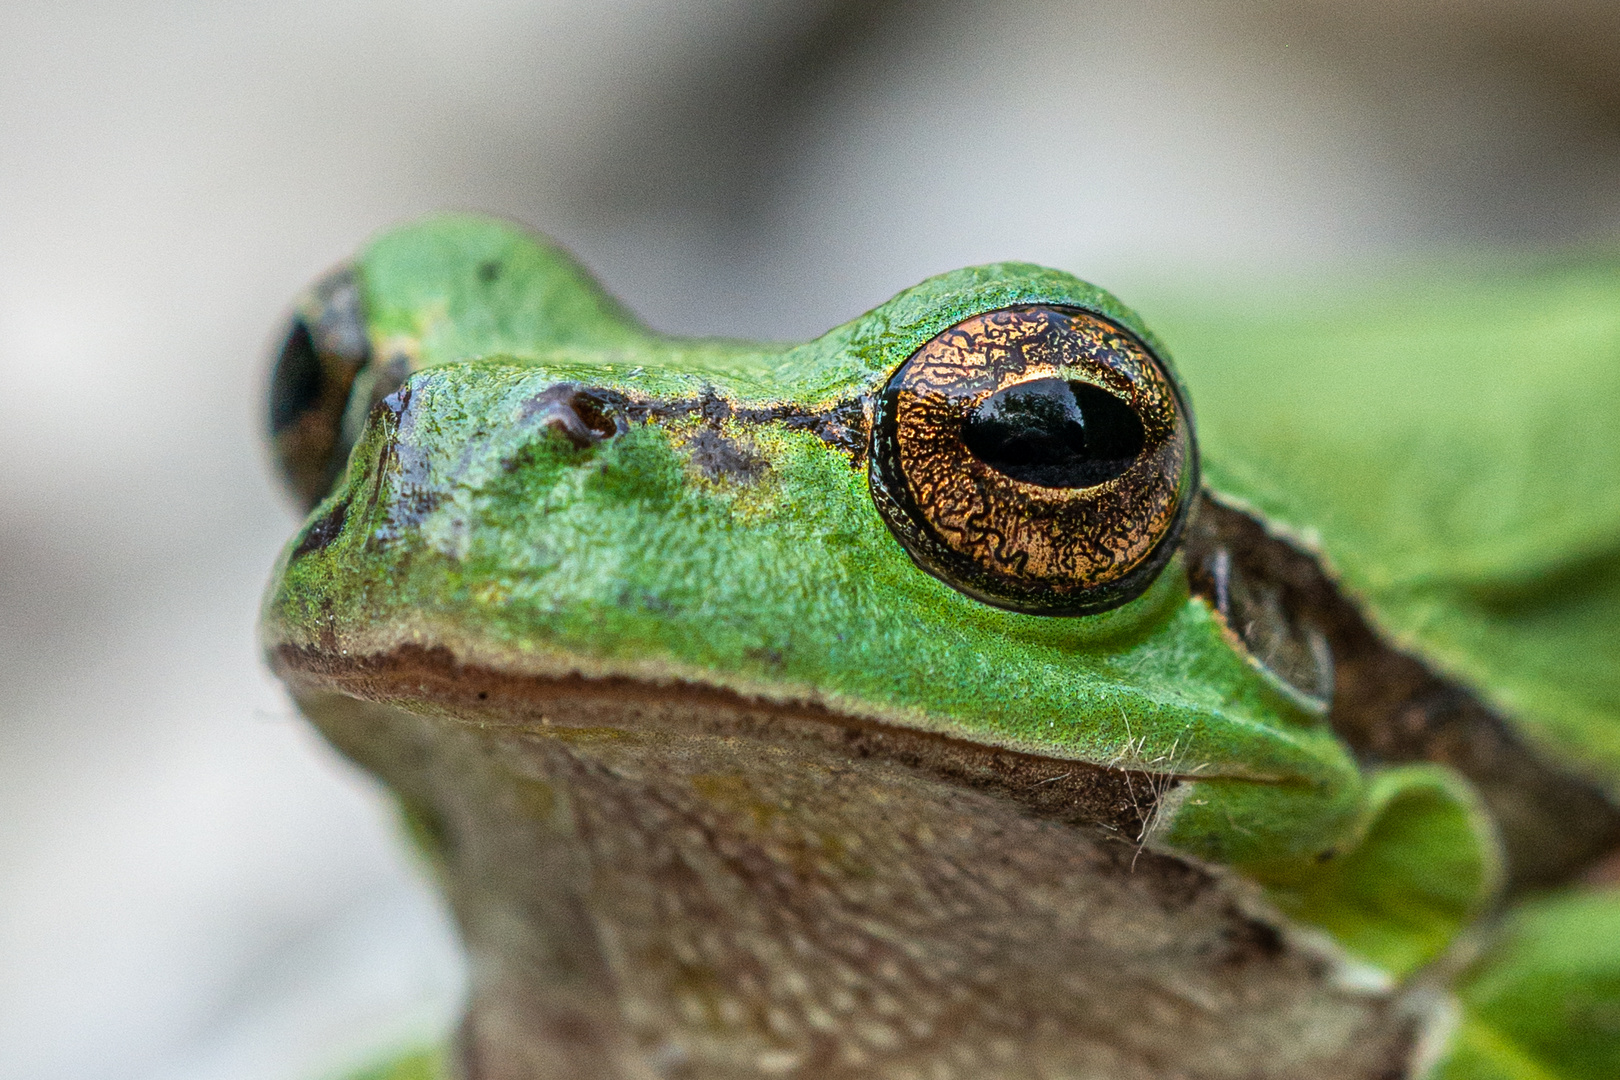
259 215 1620 1080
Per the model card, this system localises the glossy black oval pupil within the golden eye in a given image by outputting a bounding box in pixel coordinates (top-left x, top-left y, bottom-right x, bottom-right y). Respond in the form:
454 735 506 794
962 379 1147 487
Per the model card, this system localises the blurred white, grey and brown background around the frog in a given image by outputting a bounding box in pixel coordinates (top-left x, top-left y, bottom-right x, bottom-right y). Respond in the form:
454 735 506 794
0 0 1620 1080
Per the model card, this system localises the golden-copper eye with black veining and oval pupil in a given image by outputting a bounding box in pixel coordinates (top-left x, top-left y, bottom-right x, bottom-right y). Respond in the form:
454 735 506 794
870 306 1197 615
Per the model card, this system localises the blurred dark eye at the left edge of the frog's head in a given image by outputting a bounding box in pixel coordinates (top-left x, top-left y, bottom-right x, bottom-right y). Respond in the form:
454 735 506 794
269 269 371 508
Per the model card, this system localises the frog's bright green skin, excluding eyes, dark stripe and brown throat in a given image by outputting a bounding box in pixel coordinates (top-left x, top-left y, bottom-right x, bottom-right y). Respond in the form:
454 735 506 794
262 217 1620 1075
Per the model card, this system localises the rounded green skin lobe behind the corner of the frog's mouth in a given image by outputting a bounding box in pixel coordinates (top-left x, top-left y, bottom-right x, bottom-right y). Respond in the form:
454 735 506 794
1160 764 1502 978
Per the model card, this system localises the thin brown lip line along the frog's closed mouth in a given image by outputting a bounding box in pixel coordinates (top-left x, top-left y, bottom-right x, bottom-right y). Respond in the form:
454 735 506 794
271 644 1176 844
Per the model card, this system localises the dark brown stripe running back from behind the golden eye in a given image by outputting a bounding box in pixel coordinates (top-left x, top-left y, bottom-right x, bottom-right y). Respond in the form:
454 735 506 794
1186 489 1620 892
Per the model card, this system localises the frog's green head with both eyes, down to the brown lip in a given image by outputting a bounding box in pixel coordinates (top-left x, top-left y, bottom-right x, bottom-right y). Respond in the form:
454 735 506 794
262 219 1496 984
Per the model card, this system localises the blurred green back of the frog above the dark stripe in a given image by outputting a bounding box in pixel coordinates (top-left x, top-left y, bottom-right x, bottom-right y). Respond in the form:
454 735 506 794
1155 268 1620 792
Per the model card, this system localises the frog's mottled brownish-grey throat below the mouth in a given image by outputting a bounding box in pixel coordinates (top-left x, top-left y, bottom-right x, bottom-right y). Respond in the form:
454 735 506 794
284 670 1411 1078
